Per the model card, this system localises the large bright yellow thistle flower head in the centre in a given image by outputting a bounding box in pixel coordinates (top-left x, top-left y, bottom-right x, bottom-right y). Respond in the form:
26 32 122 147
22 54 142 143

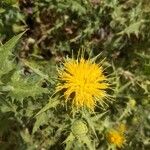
57 57 108 110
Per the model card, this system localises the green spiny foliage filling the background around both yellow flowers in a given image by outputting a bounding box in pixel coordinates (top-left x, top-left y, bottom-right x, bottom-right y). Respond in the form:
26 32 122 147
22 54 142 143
0 0 150 150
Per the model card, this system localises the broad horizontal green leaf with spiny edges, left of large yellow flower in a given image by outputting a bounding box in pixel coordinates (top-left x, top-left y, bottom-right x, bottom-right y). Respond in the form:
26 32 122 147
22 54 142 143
3 72 49 101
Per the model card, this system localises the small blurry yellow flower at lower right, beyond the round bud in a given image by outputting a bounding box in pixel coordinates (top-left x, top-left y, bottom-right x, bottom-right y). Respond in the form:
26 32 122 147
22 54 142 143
107 130 125 148
